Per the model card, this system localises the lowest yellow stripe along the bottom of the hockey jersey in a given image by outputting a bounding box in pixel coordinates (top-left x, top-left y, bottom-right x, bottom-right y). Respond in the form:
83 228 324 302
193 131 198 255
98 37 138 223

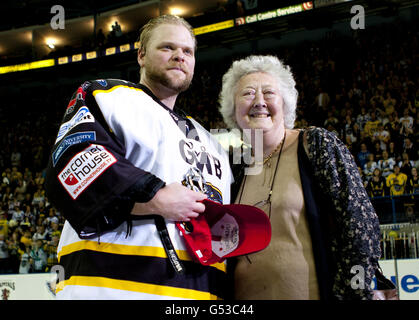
56 276 219 300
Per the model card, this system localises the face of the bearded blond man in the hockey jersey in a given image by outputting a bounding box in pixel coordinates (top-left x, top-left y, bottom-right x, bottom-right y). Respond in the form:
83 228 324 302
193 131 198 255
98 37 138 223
138 24 195 93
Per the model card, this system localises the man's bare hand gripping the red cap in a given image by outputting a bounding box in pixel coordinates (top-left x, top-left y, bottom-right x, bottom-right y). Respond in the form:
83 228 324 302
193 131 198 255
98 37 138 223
131 182 207 221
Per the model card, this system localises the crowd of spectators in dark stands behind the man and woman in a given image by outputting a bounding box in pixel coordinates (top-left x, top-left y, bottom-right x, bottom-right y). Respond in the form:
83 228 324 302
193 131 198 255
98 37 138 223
0 15 419 274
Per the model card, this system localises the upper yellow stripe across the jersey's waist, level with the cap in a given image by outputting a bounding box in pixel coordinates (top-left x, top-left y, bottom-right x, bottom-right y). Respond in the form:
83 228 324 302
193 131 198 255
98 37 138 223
58 240 226 272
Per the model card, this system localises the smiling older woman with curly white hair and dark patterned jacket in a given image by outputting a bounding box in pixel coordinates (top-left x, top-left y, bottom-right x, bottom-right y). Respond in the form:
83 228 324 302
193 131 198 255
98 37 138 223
220 56 380 300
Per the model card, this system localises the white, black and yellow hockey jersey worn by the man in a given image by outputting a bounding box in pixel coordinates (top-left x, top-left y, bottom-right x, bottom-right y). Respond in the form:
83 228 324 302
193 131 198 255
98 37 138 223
46 79 233 300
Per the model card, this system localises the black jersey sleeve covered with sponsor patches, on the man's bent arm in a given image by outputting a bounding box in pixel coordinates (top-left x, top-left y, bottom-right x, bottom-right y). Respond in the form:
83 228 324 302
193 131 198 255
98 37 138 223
45 81 165 238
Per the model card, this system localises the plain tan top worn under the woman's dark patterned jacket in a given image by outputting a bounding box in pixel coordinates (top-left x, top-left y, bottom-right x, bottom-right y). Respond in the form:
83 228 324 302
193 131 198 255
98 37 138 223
235 130 319 300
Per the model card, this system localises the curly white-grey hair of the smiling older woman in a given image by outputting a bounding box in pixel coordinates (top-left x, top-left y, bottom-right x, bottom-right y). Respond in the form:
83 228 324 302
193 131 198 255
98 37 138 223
219 55 298 129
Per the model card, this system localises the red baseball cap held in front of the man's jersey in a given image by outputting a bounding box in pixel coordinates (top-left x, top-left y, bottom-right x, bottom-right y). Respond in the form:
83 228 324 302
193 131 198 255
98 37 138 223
176 199 271 265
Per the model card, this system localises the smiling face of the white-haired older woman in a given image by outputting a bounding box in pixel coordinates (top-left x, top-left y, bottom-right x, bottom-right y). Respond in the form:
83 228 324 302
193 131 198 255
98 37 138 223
234 72 284 134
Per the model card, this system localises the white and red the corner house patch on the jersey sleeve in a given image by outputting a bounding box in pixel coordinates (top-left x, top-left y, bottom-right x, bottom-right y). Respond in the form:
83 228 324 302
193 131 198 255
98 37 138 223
58 144 117 200
